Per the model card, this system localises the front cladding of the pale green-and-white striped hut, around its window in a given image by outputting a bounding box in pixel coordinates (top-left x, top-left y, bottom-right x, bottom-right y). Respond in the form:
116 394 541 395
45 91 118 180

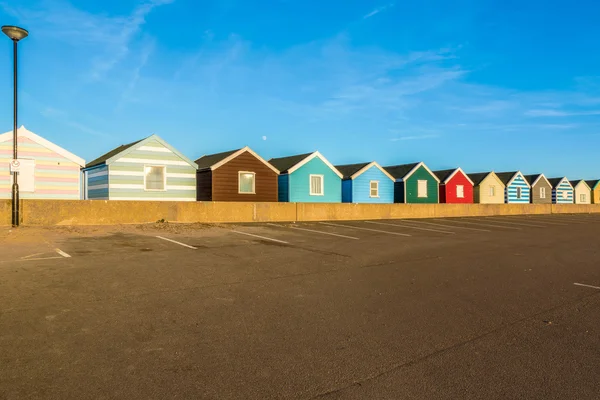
108 140 196 201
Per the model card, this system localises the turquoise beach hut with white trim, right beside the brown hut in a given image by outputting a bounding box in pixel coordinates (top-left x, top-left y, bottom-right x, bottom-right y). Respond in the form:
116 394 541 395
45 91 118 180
269 151 343 203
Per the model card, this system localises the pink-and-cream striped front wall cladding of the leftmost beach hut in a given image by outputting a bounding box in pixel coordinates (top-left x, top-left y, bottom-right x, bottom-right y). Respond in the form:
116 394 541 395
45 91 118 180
0 136 81 200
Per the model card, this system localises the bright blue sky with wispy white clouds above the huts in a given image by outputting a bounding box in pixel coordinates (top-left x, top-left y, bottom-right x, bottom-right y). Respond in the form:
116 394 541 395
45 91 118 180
0 0 600 179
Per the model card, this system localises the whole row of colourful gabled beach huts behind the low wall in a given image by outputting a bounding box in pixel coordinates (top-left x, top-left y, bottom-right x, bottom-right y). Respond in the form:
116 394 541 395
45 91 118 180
0 127 600 204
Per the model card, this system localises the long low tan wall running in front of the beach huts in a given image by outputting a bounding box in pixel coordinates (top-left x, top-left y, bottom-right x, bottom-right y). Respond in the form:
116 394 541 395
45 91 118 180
5 200 600 226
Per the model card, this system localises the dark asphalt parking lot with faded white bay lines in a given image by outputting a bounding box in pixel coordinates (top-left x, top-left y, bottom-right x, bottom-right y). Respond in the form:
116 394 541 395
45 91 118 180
0 215 600 399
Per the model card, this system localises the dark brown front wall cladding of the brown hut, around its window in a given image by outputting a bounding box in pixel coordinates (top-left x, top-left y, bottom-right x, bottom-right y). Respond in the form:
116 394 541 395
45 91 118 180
212 152 278 202
